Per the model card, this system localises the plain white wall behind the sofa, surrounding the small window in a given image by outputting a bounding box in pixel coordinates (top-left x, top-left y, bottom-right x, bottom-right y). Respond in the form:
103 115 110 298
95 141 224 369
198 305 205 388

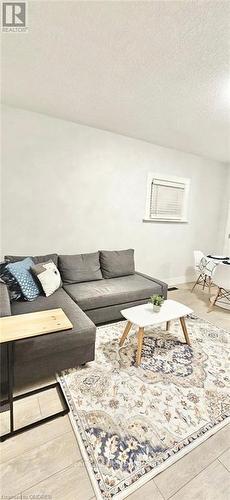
2 107 227 283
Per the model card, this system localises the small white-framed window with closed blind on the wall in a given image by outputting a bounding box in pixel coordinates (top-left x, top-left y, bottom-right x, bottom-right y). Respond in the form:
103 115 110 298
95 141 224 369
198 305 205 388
144 174 190 222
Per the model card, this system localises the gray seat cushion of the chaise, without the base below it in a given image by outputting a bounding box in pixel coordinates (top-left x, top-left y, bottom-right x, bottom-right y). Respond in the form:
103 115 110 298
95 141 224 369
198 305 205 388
11 288 96 363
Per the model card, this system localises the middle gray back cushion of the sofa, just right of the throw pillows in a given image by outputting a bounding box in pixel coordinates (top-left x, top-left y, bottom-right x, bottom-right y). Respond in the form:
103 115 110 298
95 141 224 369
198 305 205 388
58 252 103 284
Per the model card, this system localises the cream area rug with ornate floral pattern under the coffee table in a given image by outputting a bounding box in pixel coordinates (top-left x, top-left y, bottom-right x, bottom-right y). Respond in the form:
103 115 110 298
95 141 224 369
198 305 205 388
59 316 230 500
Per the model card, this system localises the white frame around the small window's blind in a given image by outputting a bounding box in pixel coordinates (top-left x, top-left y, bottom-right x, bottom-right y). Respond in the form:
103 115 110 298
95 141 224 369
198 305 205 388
143 172 190 223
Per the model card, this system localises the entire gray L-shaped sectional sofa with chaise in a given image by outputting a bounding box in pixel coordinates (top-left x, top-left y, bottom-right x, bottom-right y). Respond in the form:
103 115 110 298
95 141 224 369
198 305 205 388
0 250 167 386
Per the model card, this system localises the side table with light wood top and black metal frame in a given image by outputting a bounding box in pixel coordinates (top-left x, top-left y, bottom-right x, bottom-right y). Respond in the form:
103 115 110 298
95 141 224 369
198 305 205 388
0 308 73 441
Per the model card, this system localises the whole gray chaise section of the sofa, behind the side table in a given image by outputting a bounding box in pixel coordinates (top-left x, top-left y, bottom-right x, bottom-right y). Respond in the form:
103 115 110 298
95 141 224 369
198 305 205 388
2 288 96 386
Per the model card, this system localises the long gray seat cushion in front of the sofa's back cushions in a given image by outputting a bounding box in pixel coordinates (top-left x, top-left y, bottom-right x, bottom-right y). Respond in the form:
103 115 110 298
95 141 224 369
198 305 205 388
64 274 162 311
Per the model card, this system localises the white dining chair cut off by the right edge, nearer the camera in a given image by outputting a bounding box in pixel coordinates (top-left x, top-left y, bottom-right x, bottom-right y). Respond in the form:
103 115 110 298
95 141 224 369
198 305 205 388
209 264 230 311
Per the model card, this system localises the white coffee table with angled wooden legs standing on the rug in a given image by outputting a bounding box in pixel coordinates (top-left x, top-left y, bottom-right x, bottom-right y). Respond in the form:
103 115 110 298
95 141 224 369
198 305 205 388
119 299 193 366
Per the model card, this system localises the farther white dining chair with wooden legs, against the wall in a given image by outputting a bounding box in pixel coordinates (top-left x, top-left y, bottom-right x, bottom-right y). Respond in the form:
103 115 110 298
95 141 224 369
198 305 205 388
191 250 216 293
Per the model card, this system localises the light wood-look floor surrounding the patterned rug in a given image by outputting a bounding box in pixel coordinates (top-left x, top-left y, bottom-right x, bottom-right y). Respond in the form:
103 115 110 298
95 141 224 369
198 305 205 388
0 284 230 500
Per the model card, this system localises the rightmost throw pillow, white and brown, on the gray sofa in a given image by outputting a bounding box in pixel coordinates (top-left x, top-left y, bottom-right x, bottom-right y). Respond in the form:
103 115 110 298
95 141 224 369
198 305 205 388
31 261 62 297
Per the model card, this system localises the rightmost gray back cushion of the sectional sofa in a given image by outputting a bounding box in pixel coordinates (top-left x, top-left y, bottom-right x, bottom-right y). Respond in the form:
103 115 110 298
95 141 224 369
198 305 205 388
100 248 135 278
